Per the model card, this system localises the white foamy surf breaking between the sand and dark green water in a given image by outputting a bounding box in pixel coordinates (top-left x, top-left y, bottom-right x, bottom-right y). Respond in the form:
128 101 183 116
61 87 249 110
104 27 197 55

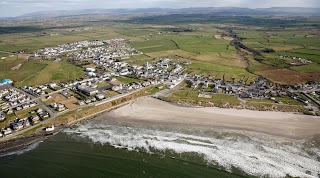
65 121 320 177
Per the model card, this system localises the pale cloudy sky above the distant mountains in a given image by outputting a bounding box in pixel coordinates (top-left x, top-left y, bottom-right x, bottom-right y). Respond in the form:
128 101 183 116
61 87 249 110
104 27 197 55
0 0 320 17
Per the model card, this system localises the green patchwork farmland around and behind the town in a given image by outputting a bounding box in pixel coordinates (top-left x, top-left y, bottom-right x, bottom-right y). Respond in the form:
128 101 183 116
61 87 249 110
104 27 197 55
0 14 320 86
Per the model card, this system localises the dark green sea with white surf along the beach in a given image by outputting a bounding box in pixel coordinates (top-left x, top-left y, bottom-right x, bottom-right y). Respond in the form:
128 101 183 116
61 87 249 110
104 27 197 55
0 116 320 178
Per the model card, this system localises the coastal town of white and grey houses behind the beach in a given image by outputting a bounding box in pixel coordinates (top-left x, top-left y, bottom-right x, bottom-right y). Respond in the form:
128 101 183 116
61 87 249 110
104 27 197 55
0 38 320 137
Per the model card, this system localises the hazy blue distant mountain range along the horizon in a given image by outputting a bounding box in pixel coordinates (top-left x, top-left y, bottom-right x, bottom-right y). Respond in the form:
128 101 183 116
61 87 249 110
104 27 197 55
5 7 320 18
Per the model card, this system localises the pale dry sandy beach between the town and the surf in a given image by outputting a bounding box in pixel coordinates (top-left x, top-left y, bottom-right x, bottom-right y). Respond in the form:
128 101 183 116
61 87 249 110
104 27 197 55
107 97 320 139
